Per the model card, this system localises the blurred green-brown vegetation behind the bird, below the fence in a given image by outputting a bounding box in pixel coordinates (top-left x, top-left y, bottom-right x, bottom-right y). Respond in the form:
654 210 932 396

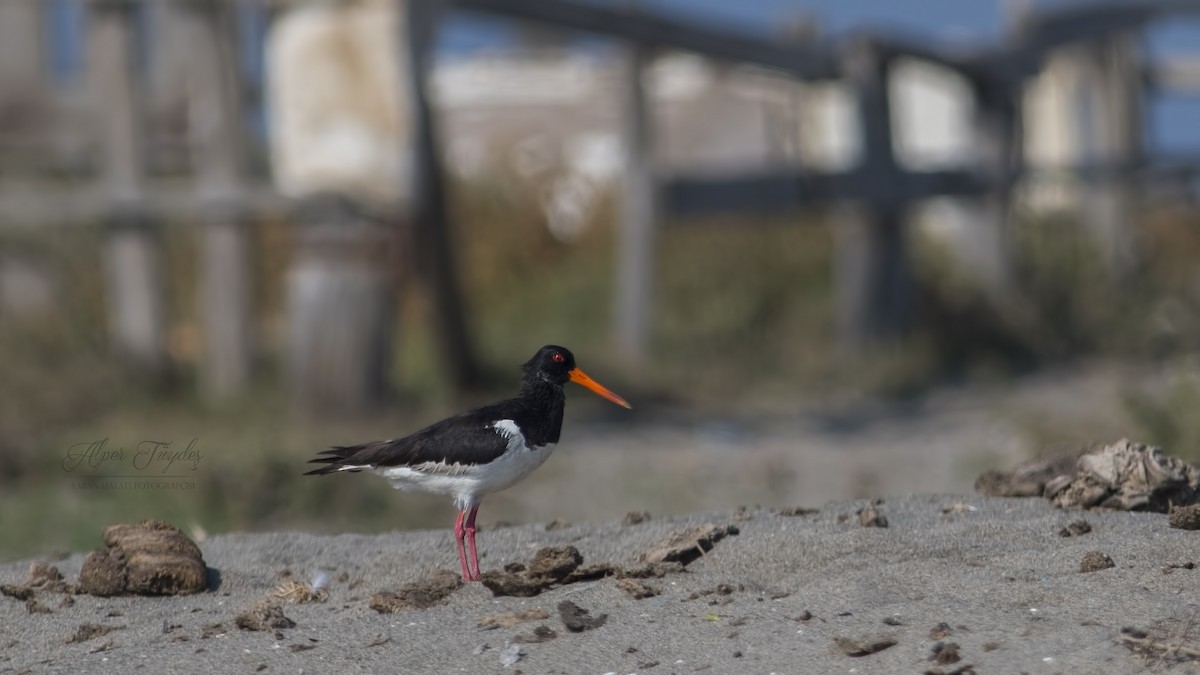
0 180 1200 560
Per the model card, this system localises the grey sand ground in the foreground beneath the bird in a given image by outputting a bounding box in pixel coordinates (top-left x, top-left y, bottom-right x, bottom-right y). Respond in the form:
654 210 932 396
0 495 1200 674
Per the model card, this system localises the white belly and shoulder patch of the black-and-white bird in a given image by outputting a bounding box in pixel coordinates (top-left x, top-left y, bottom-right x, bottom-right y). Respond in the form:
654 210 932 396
374 419 554 509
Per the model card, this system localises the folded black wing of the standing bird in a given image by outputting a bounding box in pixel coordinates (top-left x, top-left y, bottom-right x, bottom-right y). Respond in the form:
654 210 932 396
305 406 509 476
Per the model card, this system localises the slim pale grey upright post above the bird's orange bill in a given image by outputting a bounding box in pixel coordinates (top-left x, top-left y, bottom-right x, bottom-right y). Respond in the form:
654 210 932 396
616 44 659 364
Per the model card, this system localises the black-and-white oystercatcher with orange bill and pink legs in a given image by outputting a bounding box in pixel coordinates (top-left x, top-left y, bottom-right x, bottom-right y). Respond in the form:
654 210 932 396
305 345 630 581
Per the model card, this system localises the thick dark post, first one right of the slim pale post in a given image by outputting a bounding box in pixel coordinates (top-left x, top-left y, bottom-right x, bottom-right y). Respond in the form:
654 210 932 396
834 38 912 352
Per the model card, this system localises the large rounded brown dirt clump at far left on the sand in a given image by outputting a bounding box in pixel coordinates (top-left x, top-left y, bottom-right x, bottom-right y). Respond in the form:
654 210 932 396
79 520 209 597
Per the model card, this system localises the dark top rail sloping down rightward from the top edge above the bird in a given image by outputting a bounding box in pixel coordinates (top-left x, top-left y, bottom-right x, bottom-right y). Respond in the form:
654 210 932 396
451 0 835 79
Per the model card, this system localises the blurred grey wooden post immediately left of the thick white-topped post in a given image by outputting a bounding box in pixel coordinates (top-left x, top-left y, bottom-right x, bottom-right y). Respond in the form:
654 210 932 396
168 0 252 402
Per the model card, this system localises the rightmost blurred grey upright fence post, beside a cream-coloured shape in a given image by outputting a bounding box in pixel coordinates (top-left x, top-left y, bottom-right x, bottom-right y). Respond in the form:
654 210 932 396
1076 32 1144 278
